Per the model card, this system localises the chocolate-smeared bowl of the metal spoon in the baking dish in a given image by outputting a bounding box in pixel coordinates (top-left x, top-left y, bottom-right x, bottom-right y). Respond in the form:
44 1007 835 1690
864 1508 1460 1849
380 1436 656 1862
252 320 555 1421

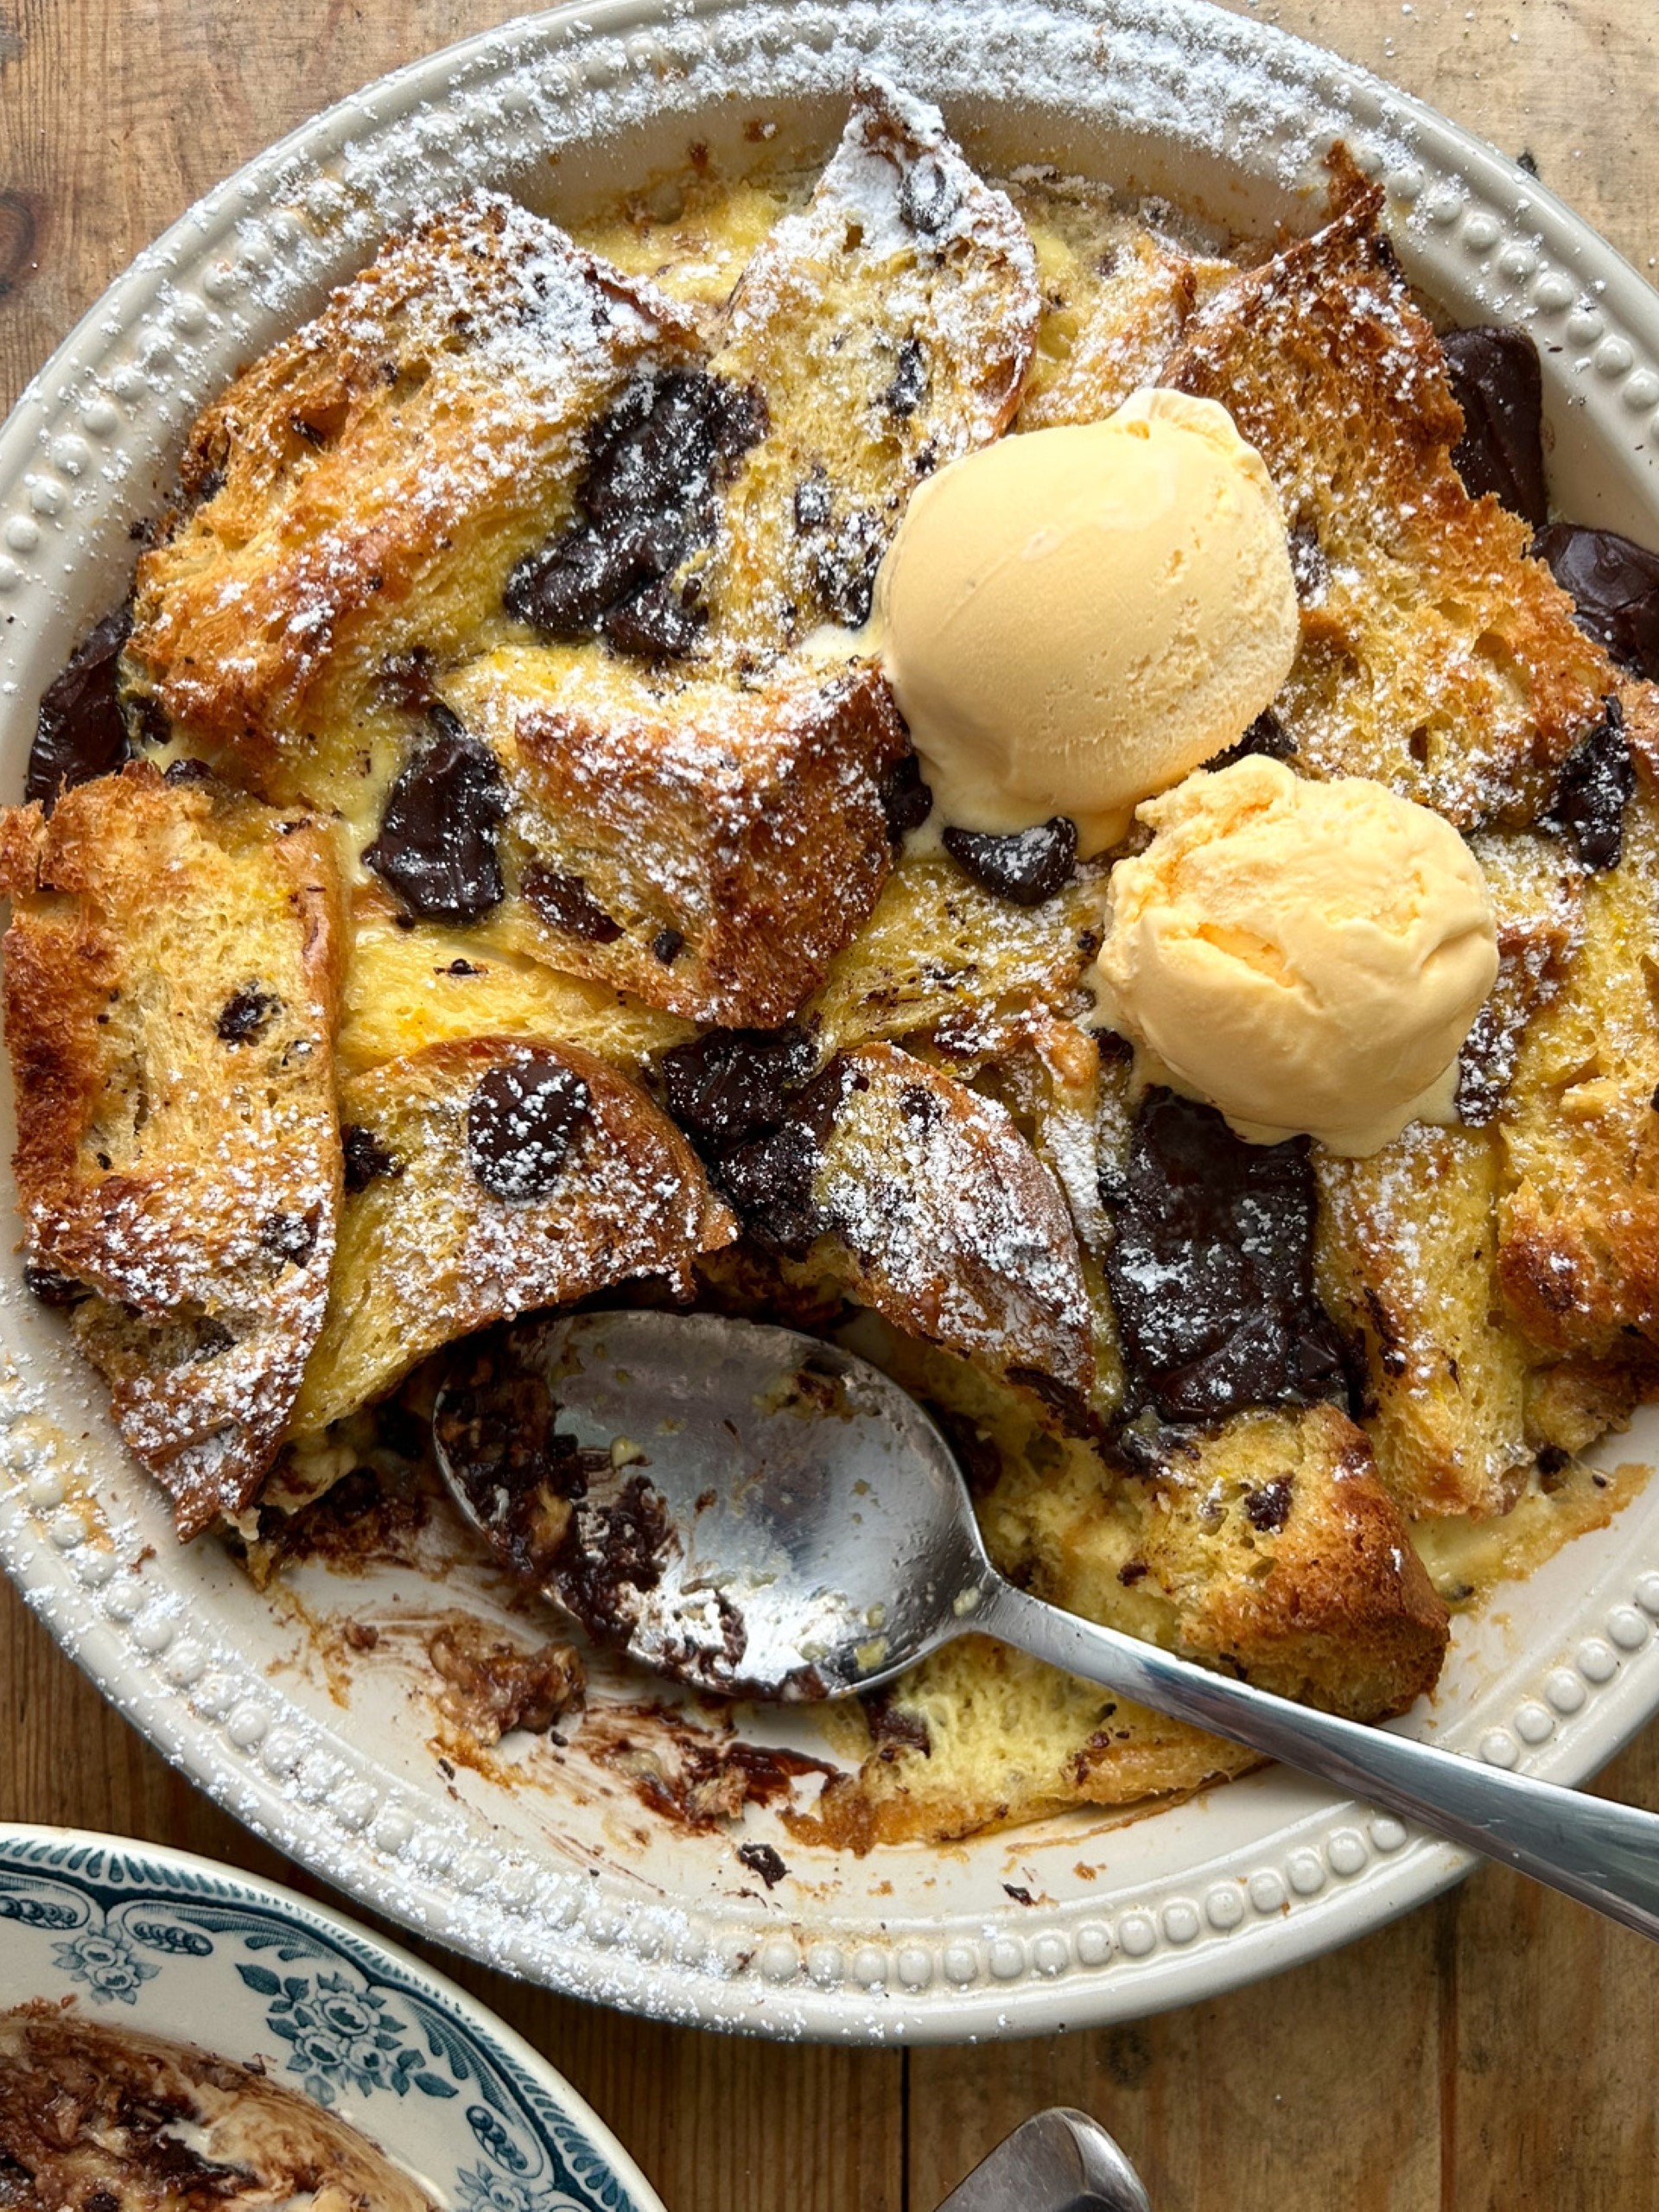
434 1312 993 1701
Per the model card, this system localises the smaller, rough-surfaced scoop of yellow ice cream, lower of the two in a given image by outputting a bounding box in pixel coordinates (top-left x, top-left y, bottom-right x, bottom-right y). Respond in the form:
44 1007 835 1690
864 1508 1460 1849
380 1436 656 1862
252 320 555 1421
1090 759 1497 1154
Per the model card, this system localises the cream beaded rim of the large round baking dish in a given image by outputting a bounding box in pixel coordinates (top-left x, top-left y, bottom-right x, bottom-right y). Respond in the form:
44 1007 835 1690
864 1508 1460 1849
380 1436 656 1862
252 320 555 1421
0 0 1659 2039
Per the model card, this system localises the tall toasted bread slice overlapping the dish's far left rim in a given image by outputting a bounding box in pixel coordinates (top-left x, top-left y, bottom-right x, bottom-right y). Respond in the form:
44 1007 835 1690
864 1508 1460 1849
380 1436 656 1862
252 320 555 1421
0 766 340 1537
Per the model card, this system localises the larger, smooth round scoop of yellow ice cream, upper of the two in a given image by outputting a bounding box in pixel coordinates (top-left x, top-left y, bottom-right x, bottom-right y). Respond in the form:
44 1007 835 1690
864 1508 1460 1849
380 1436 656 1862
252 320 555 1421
876 391 1296 854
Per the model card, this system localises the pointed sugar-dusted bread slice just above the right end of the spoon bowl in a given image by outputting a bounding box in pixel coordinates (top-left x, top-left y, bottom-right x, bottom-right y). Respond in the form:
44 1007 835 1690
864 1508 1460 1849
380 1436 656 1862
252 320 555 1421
812 1044 1095 1418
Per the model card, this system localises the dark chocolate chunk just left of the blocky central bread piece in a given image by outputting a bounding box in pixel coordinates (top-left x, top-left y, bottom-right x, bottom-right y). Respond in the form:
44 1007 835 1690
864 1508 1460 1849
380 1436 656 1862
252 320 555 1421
363 708 506 923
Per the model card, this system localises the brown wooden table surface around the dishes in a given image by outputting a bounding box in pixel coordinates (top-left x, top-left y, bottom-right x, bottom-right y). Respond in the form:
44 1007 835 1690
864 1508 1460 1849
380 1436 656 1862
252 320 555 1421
0 0 1659 2212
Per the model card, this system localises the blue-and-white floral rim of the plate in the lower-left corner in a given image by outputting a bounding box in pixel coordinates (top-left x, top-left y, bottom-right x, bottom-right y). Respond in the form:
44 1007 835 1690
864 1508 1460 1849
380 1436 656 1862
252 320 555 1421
0 1827 664 2212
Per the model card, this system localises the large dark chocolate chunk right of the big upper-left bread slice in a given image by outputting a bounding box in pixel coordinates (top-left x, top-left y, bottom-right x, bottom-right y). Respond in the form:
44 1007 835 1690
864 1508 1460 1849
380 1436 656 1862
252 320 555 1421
506 370 767 659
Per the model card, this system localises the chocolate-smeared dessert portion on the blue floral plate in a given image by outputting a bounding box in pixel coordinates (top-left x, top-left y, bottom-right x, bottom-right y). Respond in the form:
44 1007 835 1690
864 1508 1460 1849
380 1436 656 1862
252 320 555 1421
0 1999 431 2212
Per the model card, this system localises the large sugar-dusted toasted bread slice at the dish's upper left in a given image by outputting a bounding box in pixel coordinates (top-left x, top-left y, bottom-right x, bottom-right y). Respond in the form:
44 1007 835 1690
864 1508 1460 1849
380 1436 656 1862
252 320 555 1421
128 193 695 785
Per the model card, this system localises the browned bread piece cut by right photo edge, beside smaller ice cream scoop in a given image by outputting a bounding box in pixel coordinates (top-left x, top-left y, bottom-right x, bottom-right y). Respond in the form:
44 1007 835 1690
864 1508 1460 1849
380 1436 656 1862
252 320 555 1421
1497 779 1659 1360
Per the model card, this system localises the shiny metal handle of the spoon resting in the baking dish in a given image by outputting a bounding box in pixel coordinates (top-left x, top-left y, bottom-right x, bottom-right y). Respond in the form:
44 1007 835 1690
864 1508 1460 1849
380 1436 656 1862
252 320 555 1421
971 1580 1659 1938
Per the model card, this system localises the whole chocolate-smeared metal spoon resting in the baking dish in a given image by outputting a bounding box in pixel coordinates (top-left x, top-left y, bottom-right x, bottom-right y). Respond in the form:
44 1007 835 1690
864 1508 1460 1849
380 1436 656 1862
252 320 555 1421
434 1312 1659 1938
